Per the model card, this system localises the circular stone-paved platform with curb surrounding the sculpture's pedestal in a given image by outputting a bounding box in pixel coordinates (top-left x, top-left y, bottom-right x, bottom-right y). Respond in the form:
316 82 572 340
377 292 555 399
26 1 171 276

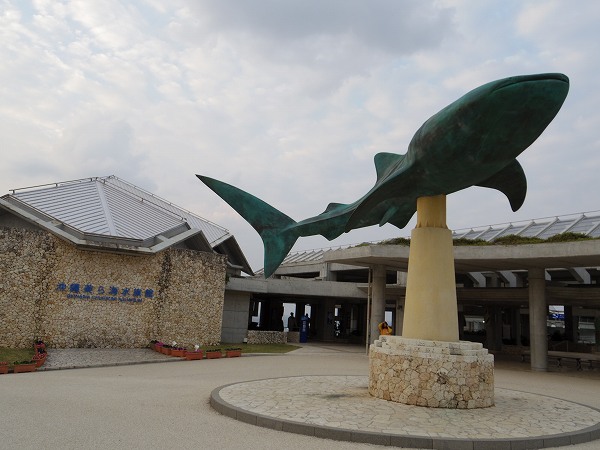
210 376 600 449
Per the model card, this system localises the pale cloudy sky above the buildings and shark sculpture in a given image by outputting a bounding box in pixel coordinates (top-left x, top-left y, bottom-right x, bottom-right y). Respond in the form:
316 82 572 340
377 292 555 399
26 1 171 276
0 0 600 270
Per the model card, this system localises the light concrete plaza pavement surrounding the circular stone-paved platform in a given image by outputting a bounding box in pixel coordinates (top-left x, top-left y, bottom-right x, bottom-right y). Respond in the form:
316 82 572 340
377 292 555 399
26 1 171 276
0 344 600 450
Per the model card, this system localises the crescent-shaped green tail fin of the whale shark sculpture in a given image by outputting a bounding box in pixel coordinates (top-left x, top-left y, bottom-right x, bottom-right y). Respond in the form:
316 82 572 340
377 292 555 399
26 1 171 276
196 175 300 278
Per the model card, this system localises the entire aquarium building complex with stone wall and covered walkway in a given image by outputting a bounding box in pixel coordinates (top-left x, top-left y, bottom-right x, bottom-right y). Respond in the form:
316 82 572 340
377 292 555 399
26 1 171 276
5 177 600 370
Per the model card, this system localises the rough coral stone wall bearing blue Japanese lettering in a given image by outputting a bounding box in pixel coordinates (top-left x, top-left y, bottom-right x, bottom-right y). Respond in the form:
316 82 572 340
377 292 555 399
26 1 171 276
0 228 225 348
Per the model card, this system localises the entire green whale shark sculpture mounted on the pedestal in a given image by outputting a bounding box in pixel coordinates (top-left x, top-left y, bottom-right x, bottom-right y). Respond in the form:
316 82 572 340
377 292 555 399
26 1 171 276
196 73 569 277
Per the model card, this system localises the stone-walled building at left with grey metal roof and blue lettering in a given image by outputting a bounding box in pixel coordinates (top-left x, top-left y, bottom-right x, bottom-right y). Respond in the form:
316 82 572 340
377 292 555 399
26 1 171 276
0 177 251 348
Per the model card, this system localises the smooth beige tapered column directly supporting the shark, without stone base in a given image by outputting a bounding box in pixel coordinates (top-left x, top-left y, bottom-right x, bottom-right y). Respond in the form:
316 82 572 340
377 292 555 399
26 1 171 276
402 195 459 342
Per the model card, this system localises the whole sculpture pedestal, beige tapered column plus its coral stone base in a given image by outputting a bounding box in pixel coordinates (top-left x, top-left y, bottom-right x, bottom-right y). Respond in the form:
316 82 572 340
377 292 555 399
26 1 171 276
369 195 494 409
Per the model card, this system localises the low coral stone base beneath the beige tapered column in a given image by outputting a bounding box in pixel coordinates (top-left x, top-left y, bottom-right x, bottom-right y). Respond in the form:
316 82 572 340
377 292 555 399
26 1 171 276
369 336 494 409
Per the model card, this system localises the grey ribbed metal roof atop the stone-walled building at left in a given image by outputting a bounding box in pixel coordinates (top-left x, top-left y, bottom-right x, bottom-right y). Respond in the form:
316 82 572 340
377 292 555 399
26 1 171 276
0 175 252 274
